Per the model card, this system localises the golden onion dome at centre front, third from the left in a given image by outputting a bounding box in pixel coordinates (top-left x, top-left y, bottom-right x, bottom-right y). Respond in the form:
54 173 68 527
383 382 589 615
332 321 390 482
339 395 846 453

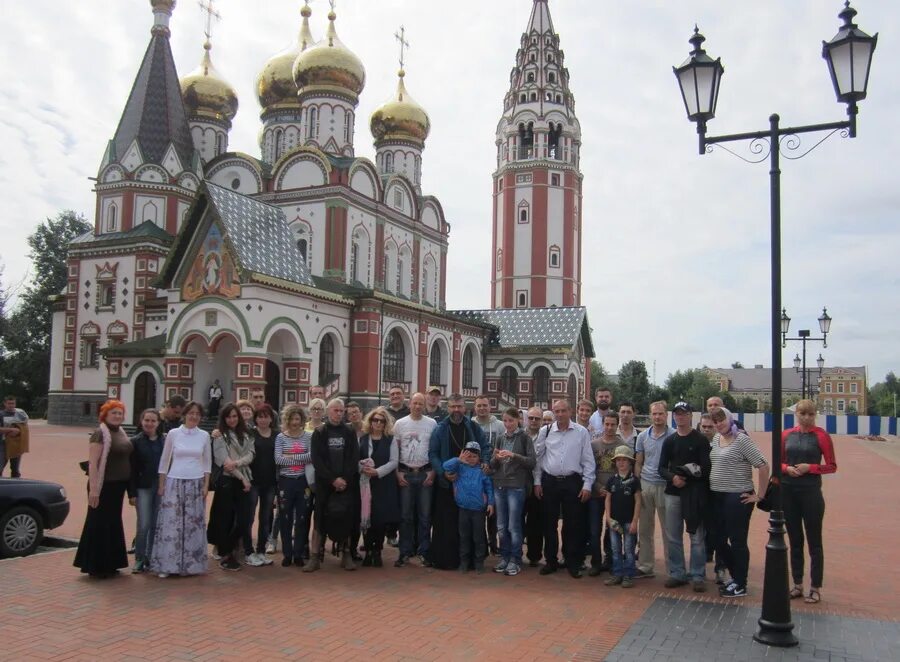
294 11 366 101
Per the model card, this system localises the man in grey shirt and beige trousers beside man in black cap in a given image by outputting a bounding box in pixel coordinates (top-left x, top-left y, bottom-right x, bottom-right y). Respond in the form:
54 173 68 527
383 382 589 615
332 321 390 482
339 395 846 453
634 400 675 579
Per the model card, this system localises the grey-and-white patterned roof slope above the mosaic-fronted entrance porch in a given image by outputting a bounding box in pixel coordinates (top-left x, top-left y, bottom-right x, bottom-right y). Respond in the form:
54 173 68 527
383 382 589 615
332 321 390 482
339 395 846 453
205 182 315 286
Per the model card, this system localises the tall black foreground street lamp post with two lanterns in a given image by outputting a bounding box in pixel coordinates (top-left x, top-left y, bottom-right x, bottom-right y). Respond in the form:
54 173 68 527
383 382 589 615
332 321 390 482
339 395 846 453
673 0 878 646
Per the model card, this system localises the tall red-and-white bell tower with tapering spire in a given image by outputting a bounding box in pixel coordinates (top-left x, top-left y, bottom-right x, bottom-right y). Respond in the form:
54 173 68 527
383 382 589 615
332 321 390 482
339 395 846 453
491 0 582 308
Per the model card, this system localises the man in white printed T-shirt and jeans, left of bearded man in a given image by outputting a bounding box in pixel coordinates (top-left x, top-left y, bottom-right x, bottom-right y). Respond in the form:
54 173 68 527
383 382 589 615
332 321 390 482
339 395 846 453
394 393 437 568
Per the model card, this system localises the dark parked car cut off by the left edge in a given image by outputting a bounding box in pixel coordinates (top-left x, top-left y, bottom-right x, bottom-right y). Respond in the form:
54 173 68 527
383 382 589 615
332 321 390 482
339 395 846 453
0 478 69 557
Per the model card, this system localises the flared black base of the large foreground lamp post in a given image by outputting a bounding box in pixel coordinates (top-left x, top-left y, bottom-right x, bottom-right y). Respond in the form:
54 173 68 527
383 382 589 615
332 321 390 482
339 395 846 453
753 510 798 648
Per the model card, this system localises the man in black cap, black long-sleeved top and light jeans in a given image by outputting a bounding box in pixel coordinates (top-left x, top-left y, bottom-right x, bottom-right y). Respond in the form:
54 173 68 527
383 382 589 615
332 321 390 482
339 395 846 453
659 401 710 593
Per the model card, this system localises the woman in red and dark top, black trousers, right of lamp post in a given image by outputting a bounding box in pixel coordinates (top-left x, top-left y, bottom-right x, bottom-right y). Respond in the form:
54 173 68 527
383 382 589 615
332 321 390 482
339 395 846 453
781 400 837 604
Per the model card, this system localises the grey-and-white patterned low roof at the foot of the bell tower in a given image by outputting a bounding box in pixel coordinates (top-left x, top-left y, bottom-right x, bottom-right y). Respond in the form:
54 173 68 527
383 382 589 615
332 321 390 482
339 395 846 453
448 306 594 356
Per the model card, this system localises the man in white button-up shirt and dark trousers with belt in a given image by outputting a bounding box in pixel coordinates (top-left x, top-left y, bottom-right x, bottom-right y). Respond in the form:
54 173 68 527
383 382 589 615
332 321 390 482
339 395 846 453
534 400 596 579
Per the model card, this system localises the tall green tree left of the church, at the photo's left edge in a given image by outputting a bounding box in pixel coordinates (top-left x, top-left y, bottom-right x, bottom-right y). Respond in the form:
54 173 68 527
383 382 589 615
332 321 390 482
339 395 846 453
4 211 91 410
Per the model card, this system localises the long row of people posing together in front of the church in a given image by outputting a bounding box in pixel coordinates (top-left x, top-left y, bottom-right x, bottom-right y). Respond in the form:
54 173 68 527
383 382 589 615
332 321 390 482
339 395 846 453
75 387 836 602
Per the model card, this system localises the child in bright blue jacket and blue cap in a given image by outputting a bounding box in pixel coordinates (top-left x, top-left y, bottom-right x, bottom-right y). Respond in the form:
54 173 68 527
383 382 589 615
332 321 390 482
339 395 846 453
443 441 494 575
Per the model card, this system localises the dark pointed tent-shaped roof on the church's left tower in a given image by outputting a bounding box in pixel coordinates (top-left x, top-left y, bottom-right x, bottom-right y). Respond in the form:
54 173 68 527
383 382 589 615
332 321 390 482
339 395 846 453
113 33 194 168
